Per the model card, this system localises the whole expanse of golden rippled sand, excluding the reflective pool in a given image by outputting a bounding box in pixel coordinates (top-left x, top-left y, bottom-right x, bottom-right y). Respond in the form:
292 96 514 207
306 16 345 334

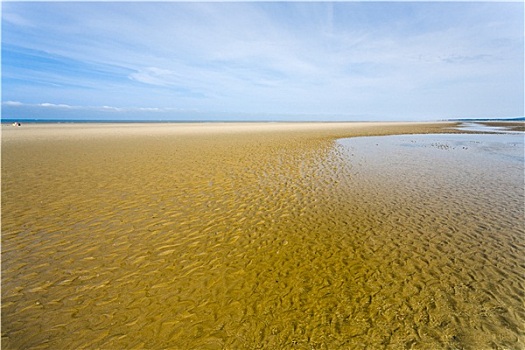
2 123 525 349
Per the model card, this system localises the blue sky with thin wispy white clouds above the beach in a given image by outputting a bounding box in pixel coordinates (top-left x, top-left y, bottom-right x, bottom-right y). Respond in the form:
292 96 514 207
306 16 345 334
1 1 524 121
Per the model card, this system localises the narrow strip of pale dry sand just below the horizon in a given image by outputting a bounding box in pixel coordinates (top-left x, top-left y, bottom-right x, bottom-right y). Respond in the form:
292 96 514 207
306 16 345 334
2 122 457 142
